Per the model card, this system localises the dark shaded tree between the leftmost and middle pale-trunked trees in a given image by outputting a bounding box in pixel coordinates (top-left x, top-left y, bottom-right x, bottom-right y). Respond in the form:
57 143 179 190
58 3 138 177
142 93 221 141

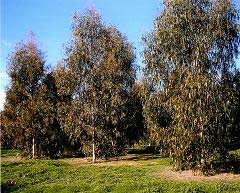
36 70 70 158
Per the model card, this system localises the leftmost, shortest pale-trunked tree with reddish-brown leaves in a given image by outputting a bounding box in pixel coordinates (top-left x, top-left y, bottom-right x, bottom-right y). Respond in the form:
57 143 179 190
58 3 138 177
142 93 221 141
4 34 45 158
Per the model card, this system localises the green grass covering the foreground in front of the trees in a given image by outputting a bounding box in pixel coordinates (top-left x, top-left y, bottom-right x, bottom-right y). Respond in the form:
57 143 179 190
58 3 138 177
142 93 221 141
1 152 240 193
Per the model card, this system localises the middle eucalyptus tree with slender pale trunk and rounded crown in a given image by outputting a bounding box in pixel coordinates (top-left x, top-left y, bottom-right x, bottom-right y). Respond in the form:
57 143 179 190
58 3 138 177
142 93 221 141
63 10 135 163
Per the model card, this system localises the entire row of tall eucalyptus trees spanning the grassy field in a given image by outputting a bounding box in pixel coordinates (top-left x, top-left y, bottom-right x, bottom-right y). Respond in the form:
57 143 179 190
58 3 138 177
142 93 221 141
1 0 240 171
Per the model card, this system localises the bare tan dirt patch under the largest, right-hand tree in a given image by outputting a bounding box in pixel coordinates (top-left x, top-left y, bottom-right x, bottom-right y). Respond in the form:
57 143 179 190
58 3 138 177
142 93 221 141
154 167 240 182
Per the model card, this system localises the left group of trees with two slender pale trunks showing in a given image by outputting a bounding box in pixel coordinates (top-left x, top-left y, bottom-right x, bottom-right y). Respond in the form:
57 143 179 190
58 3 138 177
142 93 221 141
2 10 143 162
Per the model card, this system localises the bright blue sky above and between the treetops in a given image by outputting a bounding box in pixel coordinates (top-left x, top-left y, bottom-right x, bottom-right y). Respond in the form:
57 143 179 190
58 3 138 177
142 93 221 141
0 0 240 110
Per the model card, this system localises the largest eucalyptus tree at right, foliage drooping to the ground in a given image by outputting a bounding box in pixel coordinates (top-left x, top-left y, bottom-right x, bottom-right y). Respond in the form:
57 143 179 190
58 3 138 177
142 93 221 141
143 0 239 171
